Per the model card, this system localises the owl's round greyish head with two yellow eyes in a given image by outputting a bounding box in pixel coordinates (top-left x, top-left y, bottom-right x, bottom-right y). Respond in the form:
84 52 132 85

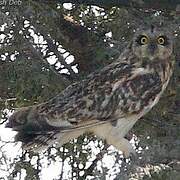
132 26 173 60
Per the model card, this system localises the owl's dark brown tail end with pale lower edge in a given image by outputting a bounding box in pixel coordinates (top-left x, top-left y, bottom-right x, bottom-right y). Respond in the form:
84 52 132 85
6 107 60 152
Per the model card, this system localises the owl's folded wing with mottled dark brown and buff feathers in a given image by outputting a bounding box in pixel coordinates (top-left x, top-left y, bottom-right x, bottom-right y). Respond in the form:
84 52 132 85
6 50 162 149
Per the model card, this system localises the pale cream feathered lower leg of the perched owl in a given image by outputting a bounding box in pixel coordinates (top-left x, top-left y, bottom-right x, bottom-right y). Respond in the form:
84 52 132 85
106 136 136 158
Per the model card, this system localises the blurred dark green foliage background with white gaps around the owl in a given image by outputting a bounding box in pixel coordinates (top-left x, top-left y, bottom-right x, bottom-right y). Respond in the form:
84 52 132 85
0 0 180 180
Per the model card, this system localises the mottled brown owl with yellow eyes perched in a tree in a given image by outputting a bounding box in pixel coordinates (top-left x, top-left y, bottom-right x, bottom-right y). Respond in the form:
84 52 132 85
6 26 174 157
